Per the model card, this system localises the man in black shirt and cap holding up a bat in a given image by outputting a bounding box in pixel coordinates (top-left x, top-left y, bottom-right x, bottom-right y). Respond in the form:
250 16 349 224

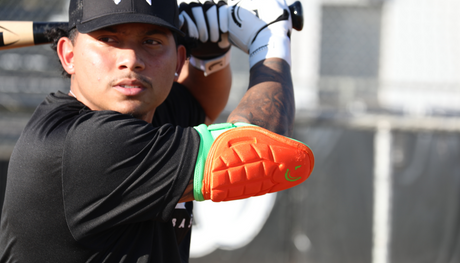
0 0 313 263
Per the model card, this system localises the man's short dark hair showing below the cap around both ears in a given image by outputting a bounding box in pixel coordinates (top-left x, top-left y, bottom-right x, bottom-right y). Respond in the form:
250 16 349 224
46 27 196 78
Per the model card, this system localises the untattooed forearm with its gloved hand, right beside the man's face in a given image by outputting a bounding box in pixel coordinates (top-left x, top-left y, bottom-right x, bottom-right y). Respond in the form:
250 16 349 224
178 0 232 125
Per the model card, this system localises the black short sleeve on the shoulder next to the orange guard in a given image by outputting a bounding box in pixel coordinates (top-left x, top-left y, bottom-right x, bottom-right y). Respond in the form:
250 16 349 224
62 111 199 244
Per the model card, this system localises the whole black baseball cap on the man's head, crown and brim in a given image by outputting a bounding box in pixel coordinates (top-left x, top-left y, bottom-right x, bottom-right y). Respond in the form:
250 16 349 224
69 0 184 36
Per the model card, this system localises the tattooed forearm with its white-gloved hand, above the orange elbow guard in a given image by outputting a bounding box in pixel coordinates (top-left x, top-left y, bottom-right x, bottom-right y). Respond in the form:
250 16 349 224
228 0 295 136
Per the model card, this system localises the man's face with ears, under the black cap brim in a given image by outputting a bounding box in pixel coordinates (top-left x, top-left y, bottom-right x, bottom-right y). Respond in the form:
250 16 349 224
58 23 185 121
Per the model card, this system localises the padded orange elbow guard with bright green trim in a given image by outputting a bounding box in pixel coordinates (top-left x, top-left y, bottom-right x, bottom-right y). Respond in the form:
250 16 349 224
194 123 314 202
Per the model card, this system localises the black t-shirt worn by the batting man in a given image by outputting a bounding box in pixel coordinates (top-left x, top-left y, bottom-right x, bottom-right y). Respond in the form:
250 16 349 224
0 84 204 263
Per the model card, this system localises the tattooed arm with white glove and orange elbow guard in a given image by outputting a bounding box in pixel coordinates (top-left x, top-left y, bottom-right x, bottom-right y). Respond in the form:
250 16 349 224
182 0 314 202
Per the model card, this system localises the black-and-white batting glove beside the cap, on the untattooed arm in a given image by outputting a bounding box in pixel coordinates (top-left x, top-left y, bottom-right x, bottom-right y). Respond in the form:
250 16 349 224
179 0 231 76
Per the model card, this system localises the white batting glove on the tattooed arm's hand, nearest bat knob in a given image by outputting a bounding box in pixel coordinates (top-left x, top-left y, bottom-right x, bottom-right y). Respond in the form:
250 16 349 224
228 0 292 68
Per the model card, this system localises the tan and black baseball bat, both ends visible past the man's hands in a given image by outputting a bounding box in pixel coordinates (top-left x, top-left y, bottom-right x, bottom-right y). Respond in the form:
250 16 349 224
0 1 303 50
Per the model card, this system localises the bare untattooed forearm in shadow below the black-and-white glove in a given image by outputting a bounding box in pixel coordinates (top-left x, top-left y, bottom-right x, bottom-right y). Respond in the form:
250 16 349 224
178 61 232 124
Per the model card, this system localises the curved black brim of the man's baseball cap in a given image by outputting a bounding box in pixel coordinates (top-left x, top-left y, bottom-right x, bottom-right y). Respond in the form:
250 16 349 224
77 14 185 36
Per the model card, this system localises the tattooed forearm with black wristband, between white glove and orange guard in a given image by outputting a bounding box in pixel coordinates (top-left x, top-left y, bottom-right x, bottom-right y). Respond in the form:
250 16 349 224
227 58 295 136
